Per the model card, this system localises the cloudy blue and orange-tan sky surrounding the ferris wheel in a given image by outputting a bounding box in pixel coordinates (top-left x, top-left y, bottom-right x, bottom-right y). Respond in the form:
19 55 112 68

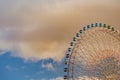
0 0 120 80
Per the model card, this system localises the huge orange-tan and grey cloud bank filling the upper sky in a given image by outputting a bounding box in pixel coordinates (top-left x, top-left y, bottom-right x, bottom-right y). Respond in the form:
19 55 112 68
0 0 120 61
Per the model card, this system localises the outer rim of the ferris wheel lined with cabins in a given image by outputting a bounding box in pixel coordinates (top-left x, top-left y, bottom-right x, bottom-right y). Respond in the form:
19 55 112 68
64 23 120 80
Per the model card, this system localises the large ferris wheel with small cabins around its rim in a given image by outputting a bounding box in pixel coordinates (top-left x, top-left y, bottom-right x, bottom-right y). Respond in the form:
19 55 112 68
64 23 120 80
